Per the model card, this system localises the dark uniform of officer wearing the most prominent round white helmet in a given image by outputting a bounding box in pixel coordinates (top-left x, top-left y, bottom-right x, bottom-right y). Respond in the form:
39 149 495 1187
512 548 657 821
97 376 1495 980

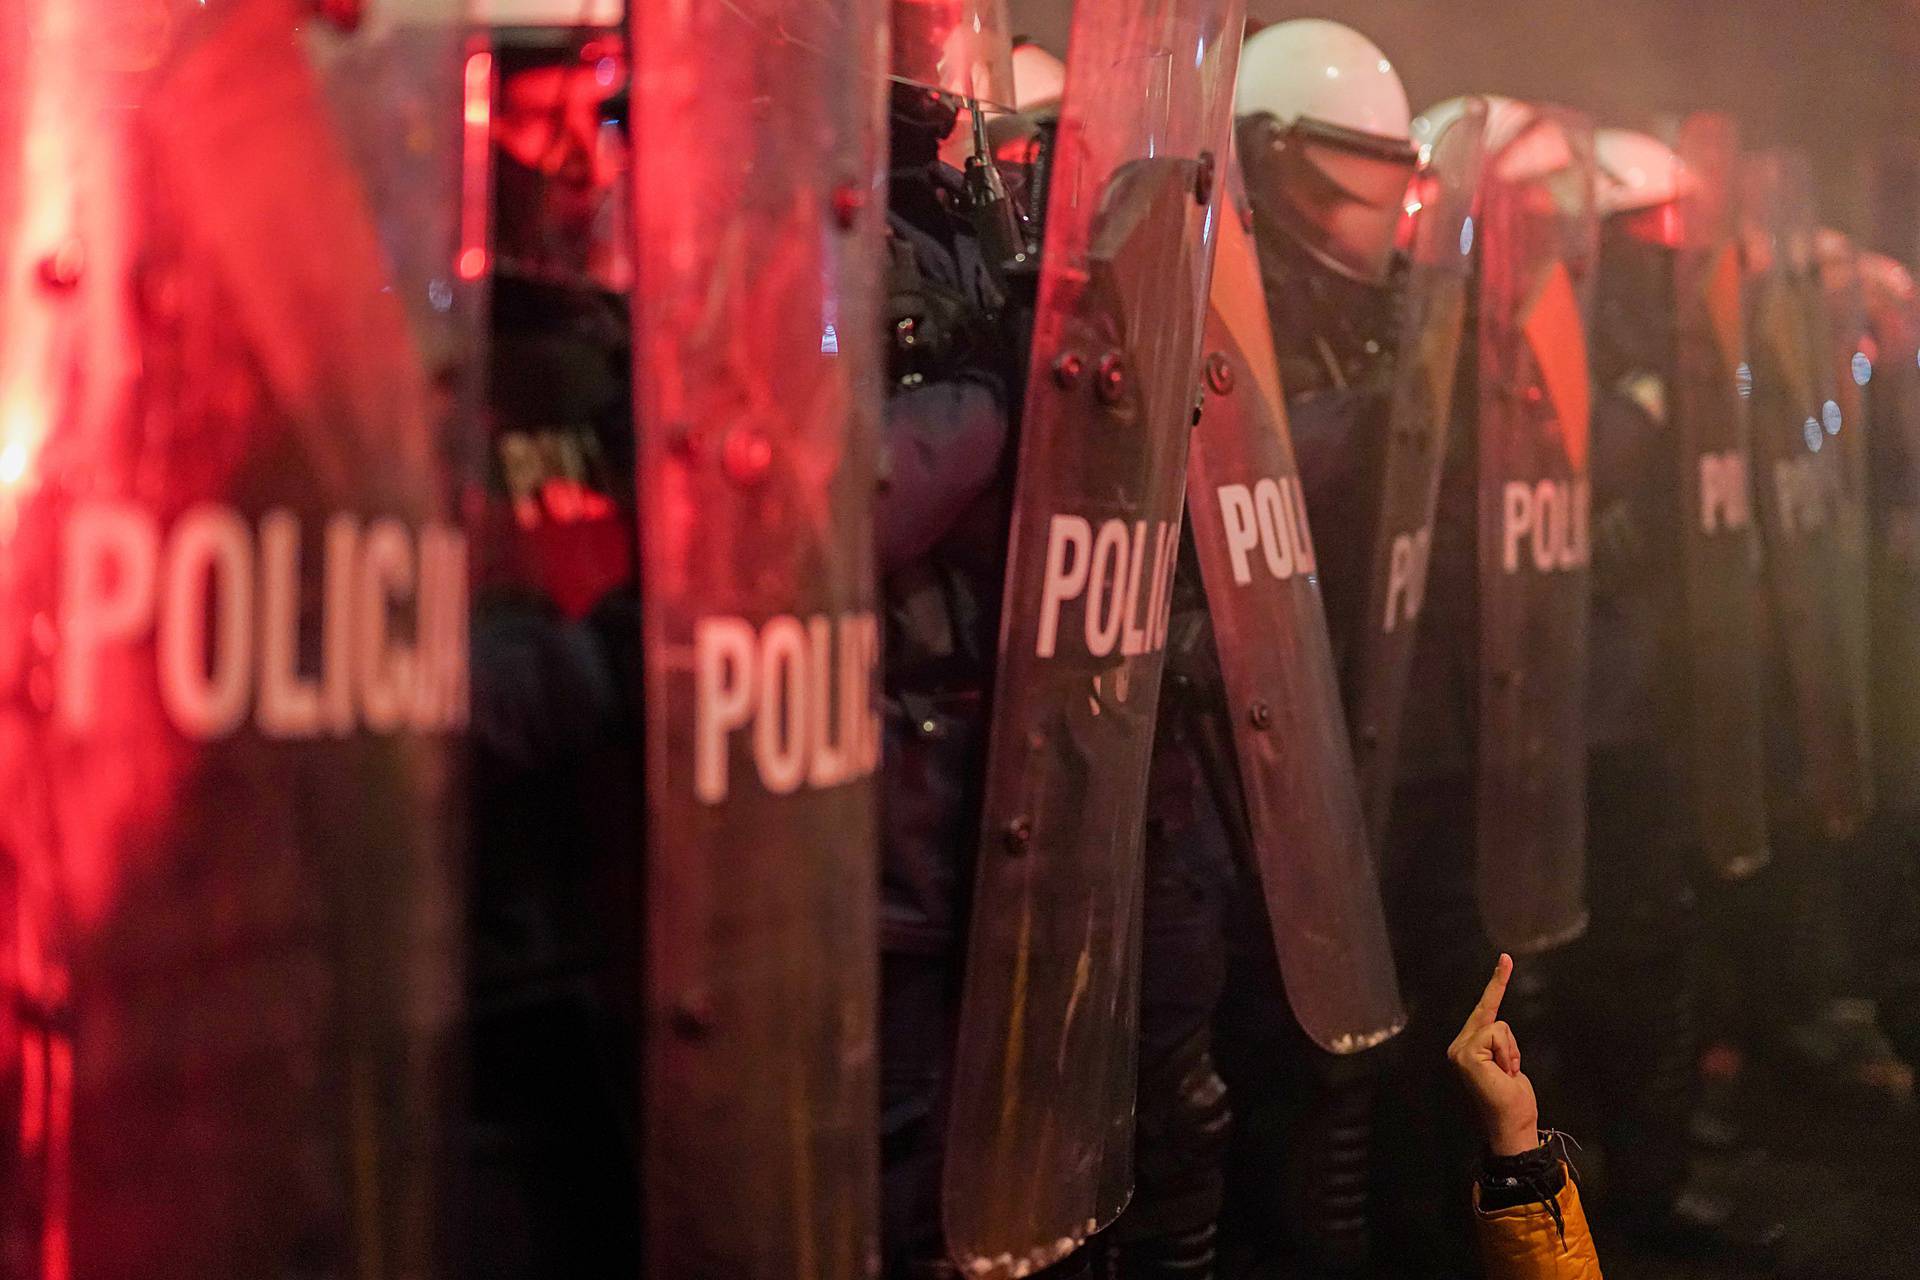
1219 117 1492 1274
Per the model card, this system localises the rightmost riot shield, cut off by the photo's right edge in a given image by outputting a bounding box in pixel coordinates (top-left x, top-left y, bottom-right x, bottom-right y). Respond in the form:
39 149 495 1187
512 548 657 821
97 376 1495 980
1862 255 1920 814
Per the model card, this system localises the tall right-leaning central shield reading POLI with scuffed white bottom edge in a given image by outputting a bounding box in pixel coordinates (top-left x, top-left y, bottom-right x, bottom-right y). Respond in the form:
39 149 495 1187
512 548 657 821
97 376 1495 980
945 0 1242 1276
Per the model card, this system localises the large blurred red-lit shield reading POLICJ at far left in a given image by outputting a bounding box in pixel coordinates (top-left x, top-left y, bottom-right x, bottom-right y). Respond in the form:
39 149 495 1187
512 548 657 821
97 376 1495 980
0 0 472 1280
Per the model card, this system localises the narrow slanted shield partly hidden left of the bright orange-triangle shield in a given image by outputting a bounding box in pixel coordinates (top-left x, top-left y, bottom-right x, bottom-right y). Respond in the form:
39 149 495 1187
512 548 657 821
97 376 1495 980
1346 100 1486 848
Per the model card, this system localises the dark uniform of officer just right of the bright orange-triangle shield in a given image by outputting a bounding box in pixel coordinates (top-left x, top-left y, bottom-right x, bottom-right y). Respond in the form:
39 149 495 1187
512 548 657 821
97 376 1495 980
1561 226 1701 1215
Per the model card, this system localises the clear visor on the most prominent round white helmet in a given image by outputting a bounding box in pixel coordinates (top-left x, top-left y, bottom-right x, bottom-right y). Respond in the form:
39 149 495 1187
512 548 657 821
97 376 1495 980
1263 117 1419 284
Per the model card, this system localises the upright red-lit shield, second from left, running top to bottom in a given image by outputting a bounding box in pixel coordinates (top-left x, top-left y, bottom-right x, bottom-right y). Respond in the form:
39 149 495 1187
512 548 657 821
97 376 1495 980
632 0 885 1280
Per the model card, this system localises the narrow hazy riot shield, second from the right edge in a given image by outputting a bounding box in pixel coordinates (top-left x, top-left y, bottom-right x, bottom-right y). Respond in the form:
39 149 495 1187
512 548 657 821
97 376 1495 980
1809 228 1874 785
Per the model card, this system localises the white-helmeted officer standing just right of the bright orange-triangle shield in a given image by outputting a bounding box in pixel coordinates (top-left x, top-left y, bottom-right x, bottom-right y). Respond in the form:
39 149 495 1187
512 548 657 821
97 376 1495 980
1557 129 1778 1259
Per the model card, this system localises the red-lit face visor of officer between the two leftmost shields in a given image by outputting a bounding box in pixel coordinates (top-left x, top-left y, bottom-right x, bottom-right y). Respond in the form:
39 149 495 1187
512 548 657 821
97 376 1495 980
493 33 634 292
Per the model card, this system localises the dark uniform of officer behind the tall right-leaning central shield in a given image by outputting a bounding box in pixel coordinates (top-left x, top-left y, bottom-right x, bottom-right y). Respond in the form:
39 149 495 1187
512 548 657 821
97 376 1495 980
877 92 1231 1280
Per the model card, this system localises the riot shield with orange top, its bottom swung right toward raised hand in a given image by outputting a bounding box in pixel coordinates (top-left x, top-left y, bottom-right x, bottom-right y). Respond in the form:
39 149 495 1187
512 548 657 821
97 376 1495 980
1187 165 1405 1054
